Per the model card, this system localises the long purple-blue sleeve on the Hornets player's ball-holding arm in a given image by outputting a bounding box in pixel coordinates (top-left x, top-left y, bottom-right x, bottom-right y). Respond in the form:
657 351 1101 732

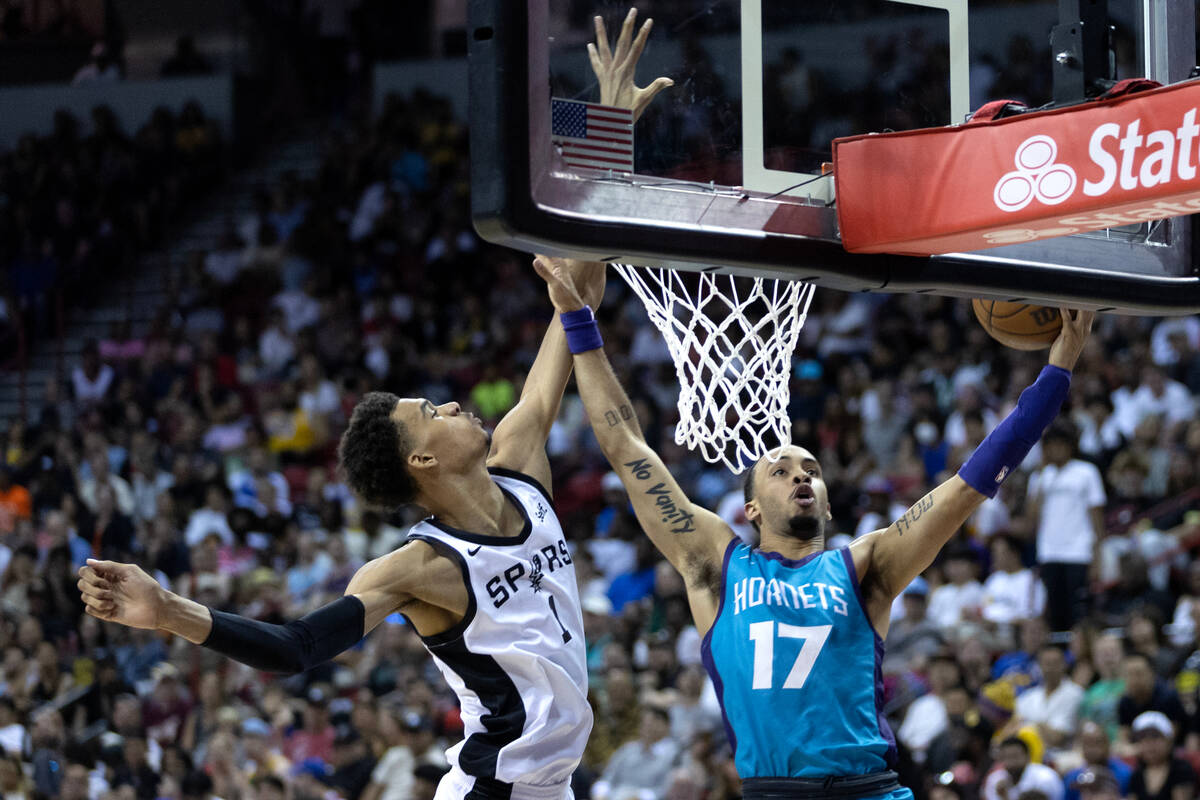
959 365 1070 498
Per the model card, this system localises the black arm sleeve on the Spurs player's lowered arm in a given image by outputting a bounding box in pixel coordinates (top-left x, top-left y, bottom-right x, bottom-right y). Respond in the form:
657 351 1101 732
203 596 366 674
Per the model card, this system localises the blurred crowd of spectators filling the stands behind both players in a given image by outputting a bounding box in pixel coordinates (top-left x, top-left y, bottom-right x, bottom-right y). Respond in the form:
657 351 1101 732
0 74 1200 800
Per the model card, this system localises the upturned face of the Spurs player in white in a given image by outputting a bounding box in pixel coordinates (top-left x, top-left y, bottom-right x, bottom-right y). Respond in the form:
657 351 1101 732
392 398 492 471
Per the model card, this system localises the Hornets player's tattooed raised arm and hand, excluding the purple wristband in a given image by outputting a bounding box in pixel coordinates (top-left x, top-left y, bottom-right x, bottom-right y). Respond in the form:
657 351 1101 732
534 258 733 628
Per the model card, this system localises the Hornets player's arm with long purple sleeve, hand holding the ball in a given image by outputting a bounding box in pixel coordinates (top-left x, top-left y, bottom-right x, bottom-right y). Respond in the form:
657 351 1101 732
870 309 1094 597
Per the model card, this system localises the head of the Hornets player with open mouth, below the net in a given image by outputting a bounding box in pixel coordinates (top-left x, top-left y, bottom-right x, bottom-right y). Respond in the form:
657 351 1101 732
746 445 833 541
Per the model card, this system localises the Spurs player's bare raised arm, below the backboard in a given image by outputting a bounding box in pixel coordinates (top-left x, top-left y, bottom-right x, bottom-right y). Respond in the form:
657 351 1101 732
487 259 605 491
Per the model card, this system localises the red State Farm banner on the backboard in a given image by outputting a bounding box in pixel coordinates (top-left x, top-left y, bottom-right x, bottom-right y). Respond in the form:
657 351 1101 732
833 82 1200 255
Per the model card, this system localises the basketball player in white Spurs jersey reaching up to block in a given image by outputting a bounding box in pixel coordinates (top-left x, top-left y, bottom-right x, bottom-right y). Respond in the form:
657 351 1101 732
79 20 671 800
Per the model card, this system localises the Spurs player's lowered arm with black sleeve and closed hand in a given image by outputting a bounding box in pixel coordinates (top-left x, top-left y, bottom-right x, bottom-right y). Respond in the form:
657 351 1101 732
78 543 453 674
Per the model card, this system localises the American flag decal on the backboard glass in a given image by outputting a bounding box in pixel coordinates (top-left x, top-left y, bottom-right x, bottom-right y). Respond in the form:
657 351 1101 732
550 97 634 173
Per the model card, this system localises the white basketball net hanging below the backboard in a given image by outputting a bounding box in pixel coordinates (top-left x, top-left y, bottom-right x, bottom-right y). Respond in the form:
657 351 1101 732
614 264 814 474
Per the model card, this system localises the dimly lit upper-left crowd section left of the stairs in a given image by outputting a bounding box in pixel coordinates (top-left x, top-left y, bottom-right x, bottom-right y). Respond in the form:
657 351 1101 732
0 103 226 366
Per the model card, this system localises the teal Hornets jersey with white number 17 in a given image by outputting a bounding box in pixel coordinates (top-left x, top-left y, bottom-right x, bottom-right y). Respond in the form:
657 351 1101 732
701 539 912 782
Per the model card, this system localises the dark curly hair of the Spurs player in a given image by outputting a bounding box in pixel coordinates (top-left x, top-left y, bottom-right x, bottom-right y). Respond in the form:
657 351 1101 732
337 392 416 511
